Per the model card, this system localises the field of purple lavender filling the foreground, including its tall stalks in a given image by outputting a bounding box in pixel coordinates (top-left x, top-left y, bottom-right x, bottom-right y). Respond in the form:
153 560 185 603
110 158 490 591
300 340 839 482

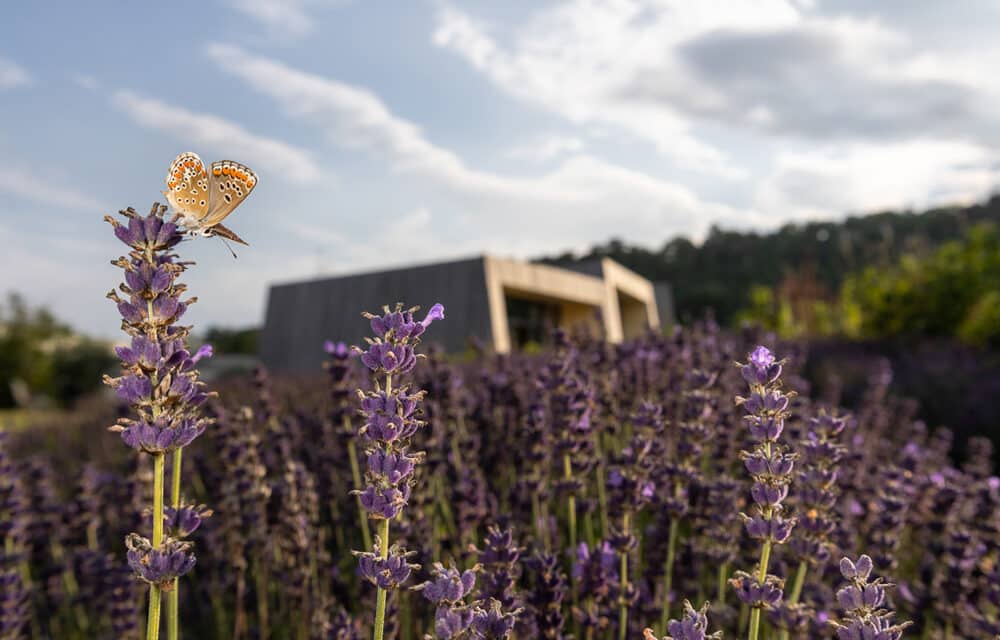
0 207 1000 640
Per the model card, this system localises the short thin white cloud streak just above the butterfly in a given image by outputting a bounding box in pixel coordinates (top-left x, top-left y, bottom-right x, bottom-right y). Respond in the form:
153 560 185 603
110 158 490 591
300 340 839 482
112 90 322 184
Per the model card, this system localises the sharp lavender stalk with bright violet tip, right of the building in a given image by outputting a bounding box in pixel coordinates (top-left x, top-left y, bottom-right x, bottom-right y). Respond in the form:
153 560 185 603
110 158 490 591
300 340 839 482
730 346 795 640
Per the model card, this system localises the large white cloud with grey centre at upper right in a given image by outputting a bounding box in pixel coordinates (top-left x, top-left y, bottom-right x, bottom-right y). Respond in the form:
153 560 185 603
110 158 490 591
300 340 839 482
432 0 1000 184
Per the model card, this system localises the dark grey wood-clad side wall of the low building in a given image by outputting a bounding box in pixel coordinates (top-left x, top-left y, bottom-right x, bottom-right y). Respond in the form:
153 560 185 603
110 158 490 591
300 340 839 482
260 256 492 373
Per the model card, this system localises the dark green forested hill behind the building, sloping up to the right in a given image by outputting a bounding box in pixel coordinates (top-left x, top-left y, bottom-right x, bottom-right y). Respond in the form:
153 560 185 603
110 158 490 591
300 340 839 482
542 195 1000 324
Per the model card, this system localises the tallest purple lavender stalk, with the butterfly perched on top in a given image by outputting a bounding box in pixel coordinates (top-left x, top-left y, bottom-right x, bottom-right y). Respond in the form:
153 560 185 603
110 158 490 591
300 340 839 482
105 204 211 640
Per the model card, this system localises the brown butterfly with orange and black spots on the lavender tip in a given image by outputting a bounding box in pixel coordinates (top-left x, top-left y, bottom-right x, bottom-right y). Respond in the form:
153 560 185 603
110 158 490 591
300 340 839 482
163 151 257 246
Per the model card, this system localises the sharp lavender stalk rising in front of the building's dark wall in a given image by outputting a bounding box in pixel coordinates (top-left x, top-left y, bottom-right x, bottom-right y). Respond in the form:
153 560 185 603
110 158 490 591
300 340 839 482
356 304 444 640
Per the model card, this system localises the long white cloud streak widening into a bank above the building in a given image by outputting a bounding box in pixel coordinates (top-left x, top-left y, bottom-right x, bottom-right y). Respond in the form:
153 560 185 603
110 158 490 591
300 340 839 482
209 44 752 254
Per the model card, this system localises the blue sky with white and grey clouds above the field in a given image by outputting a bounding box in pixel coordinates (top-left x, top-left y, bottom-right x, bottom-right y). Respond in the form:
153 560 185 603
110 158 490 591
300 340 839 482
0 0 1000 337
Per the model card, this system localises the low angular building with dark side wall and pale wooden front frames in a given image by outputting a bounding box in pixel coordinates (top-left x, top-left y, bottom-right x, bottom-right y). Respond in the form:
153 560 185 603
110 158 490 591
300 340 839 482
260 251 660 372
